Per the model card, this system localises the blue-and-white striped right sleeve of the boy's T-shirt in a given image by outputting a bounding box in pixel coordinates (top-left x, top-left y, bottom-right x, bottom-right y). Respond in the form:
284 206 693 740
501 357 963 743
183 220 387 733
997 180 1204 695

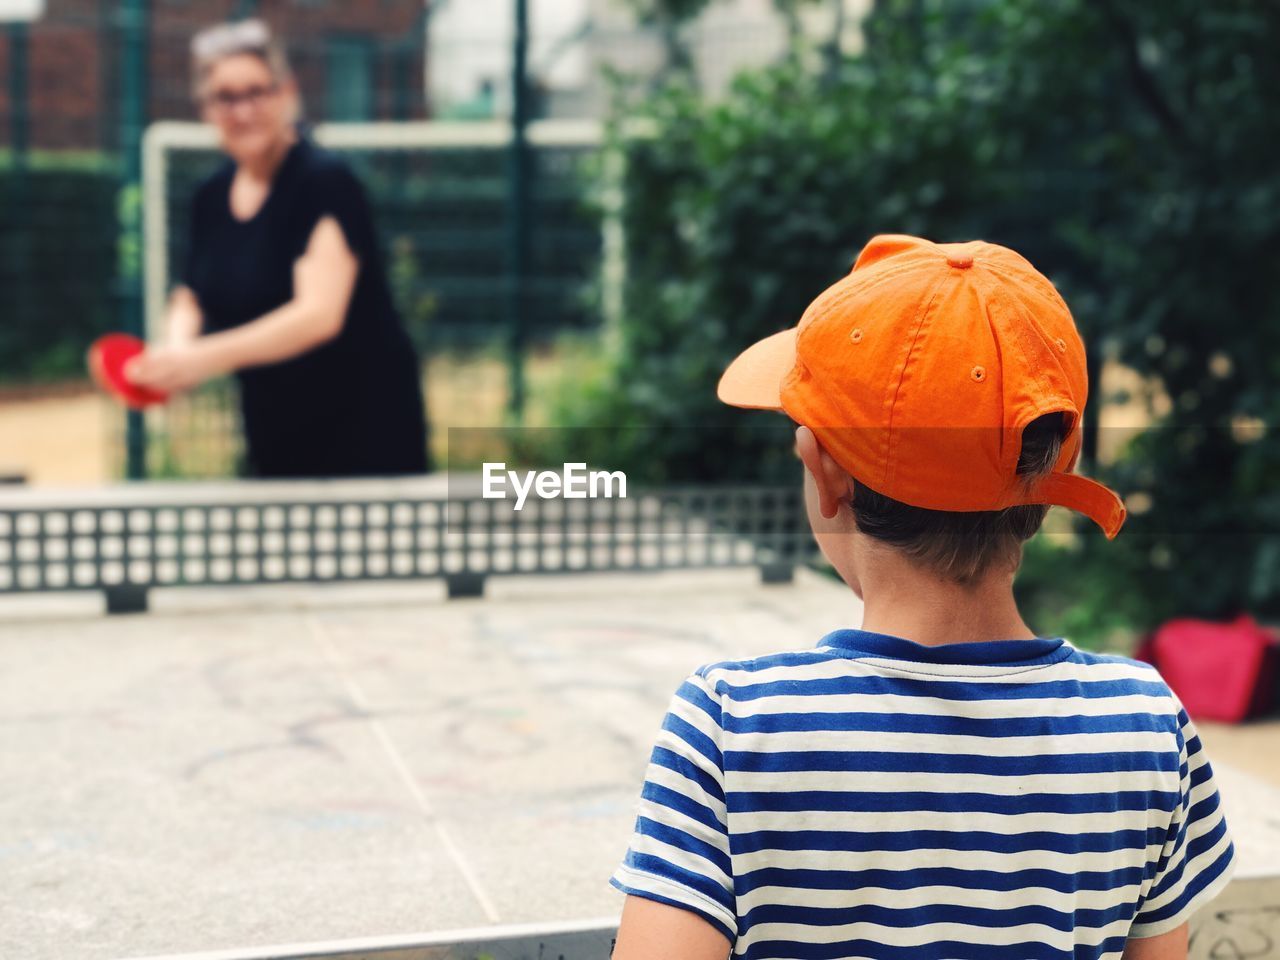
1129 696 1235 937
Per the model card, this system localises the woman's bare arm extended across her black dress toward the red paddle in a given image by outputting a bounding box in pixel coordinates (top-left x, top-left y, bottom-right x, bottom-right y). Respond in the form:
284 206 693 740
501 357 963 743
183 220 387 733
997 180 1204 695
125 216 360 393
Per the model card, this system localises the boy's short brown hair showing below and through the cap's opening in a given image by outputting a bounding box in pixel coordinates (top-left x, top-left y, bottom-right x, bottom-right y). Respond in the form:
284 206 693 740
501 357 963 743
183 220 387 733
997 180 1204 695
851 413 1068 586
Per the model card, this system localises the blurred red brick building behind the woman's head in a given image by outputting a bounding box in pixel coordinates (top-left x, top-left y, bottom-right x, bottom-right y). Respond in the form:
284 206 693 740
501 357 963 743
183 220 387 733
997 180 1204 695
0 0 426 151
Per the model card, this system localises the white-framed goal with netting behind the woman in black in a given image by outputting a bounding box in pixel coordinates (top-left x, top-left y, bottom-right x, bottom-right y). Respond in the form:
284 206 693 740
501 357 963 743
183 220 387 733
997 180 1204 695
133 120 609 479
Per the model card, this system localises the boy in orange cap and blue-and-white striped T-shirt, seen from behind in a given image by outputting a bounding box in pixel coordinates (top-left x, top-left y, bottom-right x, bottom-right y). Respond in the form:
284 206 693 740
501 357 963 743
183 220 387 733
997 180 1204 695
611 236 1234 960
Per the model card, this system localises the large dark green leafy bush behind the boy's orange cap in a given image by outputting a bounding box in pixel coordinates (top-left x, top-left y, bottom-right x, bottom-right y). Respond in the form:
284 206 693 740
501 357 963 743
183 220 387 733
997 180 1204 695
550 0 1280 640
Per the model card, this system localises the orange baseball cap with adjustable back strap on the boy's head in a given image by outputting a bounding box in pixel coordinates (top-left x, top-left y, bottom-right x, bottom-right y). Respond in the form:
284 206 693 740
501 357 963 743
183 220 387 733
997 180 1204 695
717 234 1125 540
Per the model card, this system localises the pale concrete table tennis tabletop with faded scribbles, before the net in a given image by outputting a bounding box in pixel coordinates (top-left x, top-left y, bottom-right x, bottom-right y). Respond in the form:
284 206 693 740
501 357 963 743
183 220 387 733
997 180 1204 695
0 570 1280 960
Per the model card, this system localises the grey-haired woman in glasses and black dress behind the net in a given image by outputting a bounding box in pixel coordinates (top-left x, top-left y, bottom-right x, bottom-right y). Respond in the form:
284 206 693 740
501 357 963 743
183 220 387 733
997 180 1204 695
125 20 428 477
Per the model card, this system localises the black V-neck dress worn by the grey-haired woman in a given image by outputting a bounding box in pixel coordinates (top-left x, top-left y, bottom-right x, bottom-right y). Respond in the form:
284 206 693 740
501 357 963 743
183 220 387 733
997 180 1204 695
183 136 428 477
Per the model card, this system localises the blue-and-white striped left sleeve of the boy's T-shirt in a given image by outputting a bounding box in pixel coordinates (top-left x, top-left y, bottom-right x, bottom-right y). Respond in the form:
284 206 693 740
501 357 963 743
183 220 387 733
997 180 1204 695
609 672 737 943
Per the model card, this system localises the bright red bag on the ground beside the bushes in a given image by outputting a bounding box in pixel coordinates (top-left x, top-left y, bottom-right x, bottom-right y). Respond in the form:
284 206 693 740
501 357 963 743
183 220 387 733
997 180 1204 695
1135 614 1280 723
